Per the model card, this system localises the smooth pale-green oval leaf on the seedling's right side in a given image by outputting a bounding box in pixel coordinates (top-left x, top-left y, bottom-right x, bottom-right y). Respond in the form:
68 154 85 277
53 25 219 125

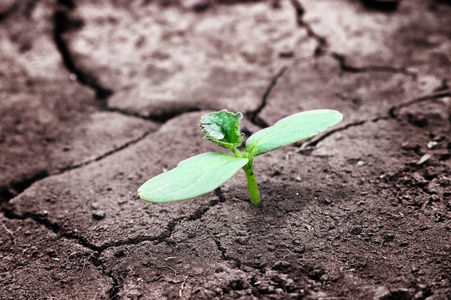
246 109 343 157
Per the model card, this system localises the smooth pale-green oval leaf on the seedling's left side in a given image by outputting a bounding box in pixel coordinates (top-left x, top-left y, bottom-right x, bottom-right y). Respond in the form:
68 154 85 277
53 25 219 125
138 152 248 203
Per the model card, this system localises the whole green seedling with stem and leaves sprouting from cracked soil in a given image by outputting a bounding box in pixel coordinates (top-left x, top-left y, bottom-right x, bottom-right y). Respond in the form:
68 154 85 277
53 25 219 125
138 109 343 206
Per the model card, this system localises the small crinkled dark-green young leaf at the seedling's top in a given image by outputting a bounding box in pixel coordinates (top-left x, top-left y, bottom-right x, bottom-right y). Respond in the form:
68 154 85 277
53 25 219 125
199 109 243 149
